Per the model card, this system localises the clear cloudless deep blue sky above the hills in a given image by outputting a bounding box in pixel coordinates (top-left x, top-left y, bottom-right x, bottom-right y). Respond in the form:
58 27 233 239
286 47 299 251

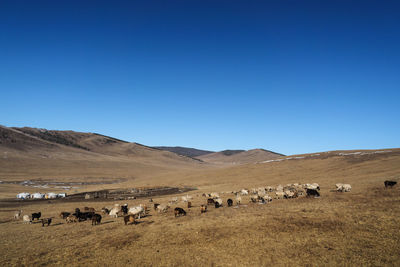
0 0 400 154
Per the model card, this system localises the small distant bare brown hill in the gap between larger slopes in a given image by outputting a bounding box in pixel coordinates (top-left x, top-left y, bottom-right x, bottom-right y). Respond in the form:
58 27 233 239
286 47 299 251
197 149 284 164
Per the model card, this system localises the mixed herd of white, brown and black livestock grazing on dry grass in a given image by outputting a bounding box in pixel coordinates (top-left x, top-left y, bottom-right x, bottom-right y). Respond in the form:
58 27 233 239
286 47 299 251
10 181 397 227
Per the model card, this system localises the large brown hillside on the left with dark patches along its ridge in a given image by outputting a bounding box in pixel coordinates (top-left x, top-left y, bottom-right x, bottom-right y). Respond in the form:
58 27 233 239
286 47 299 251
0 126 204 183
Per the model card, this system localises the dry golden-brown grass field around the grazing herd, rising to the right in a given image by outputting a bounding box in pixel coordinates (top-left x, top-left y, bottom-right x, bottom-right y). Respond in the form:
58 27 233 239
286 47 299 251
0 149 400 266
